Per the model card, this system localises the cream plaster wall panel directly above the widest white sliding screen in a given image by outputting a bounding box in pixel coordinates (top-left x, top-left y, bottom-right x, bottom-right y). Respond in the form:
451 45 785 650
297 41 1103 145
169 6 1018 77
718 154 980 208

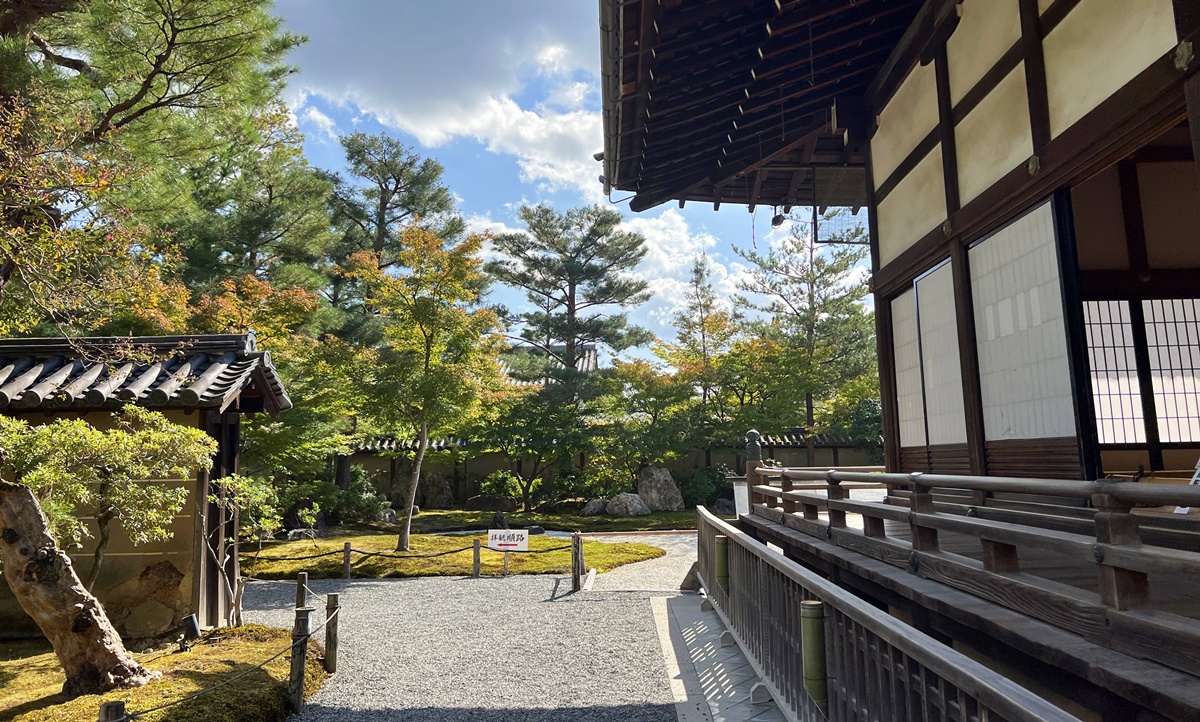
954 62 1033 205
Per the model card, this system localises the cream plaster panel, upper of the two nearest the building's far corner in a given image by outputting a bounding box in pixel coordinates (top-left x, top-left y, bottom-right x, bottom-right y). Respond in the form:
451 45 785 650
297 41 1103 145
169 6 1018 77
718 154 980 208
871 62 937 188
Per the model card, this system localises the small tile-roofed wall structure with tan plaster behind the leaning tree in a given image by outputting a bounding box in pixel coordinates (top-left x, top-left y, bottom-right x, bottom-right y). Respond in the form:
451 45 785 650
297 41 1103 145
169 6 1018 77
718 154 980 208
0 332 292 638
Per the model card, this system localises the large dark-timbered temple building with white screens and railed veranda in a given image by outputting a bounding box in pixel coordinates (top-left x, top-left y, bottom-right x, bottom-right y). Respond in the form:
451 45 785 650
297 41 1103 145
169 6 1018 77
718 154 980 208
600 0 1200 722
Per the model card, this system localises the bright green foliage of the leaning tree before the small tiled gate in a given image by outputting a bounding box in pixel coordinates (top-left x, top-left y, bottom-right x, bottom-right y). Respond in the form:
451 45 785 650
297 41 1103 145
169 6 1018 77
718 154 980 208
0 407 216 544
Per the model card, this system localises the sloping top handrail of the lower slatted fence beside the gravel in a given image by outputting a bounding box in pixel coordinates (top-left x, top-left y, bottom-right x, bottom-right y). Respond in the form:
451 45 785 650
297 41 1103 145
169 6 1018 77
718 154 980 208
698 507 1079 722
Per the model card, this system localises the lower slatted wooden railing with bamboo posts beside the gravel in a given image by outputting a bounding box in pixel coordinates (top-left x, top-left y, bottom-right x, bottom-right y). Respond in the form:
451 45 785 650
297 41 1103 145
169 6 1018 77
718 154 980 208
697 509 1078 722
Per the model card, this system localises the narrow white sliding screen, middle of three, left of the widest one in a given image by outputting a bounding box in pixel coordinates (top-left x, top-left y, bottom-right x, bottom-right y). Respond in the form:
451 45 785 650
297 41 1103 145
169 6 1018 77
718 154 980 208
916 263 967 445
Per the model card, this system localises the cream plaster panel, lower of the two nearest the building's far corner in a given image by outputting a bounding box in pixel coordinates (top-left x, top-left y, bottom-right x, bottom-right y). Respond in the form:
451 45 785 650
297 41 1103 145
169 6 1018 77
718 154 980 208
877 145 947 266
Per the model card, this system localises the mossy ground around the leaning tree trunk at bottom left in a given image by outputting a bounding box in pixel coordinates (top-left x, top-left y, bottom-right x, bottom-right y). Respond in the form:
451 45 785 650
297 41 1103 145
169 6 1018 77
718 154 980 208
0 625 325 722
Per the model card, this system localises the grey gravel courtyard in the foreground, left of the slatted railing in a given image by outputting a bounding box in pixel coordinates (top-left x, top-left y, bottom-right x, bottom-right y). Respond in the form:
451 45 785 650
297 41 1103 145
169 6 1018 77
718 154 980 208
238 570 681 722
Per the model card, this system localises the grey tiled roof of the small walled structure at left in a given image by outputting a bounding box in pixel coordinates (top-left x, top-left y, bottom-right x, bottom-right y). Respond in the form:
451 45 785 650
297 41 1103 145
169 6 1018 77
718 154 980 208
0 333 292 413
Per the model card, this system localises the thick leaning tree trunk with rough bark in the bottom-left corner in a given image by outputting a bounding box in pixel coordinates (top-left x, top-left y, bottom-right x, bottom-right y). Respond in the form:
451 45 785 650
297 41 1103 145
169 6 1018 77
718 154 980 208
0 481 158 697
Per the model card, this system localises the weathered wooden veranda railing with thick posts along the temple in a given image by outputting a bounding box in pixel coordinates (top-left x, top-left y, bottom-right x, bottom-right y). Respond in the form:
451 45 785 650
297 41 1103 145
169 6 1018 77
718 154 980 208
751 469 1200 675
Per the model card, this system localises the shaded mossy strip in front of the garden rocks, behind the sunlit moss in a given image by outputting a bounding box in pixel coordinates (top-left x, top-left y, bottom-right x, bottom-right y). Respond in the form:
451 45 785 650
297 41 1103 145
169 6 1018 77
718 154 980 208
413 509 696 533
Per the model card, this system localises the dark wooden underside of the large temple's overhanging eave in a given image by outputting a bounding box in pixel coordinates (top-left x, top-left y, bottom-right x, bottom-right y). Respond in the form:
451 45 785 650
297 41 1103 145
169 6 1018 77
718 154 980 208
600 0 922 211
